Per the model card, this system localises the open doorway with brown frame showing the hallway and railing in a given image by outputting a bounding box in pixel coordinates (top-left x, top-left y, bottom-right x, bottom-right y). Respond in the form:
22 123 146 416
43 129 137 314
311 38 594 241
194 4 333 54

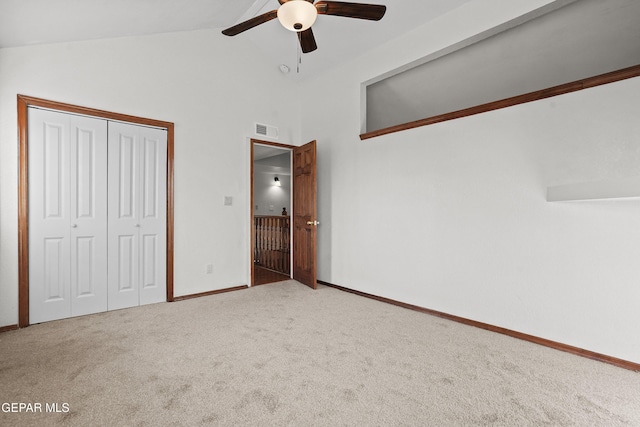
251 139 293 286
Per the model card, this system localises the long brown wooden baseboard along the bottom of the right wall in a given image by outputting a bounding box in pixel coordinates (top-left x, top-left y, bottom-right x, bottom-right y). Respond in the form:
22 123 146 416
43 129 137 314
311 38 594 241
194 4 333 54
318 280 640 372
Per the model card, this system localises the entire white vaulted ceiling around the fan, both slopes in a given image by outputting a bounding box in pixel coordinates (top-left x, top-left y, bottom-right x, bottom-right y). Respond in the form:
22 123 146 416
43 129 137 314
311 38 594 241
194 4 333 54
0 0 471 74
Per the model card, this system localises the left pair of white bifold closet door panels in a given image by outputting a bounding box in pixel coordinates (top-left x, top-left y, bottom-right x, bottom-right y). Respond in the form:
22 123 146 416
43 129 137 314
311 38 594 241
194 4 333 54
29 109 107 323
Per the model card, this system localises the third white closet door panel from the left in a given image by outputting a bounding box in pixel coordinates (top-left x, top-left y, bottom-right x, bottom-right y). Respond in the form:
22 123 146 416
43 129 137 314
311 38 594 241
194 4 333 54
108 122 140 310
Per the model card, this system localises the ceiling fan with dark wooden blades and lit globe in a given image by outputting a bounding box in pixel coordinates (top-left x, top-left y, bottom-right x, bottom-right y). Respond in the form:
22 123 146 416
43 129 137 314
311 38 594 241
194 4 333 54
222 0 387 53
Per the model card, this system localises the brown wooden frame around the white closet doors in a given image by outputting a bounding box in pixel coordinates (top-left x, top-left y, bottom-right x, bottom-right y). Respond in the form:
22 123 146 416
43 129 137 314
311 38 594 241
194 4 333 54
18 95 174 328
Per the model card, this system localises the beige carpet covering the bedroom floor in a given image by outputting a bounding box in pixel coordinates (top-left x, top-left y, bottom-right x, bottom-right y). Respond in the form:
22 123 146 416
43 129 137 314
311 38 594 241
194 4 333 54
0 281 640 426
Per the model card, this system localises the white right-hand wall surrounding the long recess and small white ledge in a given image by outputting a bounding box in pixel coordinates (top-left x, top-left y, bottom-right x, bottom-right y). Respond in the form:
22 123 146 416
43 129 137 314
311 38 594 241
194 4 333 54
301 0 640 363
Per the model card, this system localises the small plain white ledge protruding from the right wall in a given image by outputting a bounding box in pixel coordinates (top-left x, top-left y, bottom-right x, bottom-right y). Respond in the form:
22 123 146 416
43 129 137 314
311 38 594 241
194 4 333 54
547 176 640 202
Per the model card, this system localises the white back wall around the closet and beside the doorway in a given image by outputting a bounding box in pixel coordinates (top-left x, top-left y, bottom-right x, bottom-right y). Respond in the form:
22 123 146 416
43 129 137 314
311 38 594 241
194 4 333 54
0 30 299 326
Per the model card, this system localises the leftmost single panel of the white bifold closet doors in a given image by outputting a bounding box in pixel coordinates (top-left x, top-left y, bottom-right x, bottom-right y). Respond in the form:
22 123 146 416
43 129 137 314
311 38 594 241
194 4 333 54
28 109 71 323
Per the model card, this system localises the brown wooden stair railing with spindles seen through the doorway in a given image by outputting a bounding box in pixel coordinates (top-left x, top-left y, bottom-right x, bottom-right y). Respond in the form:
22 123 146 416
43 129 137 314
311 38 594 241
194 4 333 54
253 215 291 274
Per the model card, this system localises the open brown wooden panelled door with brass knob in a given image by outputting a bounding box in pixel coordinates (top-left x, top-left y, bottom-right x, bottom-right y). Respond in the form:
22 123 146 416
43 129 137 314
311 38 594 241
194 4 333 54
293 141 318 289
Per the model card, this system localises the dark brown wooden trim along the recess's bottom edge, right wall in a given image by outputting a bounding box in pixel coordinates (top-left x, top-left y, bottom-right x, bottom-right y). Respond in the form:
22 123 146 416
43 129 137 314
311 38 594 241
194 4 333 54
360 65 640 141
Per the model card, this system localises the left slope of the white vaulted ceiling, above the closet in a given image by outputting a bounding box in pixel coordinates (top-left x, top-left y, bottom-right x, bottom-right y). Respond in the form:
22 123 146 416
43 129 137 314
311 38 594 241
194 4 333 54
0 0 255 47
